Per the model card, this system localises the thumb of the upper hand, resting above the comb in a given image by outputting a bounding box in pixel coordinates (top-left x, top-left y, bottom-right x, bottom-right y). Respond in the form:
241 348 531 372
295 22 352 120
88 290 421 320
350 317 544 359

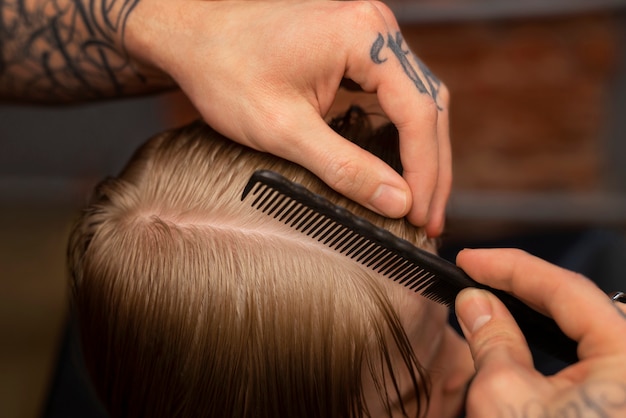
285 108 412 218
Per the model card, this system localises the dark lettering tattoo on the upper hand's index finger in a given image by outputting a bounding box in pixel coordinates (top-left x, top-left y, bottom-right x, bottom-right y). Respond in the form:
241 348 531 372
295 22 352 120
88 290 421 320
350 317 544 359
370 32 443 110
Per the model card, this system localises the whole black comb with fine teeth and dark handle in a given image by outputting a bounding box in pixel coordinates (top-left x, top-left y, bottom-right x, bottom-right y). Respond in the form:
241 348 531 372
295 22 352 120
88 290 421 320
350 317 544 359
241 170 578 364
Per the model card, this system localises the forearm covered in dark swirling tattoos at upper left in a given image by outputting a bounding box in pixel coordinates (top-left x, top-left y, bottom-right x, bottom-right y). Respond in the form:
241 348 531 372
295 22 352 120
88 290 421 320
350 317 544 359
0 0 158 102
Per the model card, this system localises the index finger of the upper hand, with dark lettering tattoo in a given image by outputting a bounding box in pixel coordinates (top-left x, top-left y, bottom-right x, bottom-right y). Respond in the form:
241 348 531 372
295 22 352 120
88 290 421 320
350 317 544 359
346 2 452 235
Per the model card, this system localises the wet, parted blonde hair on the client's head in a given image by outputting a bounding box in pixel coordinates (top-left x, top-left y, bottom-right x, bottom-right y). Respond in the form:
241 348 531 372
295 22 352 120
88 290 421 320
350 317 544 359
68 110 430 418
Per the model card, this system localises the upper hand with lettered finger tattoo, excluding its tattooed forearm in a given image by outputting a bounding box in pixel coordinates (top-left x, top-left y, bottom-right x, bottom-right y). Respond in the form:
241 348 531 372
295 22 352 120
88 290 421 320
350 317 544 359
126 0 451 235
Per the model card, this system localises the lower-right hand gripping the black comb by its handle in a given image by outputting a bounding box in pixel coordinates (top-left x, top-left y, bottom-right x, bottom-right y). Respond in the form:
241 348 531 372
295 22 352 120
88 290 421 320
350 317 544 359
456 249 626 418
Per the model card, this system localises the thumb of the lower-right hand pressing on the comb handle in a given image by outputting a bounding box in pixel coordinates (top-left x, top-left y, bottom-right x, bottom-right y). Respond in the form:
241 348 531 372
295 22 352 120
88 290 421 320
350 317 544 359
456 288 534 372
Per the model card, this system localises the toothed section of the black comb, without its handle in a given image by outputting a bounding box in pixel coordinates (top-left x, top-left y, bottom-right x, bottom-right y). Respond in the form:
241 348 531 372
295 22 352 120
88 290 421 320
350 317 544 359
242 171 469 306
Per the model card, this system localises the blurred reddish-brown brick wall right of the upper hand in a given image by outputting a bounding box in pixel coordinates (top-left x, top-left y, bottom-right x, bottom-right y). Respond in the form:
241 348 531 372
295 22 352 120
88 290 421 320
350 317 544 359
403 14 619 191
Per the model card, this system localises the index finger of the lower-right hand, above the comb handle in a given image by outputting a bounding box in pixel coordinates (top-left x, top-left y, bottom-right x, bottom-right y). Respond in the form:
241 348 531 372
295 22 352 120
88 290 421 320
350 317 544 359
457 249 626 358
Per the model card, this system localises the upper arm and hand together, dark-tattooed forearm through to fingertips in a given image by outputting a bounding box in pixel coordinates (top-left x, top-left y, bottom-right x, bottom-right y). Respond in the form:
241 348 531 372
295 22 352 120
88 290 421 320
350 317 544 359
0 0 452 236
